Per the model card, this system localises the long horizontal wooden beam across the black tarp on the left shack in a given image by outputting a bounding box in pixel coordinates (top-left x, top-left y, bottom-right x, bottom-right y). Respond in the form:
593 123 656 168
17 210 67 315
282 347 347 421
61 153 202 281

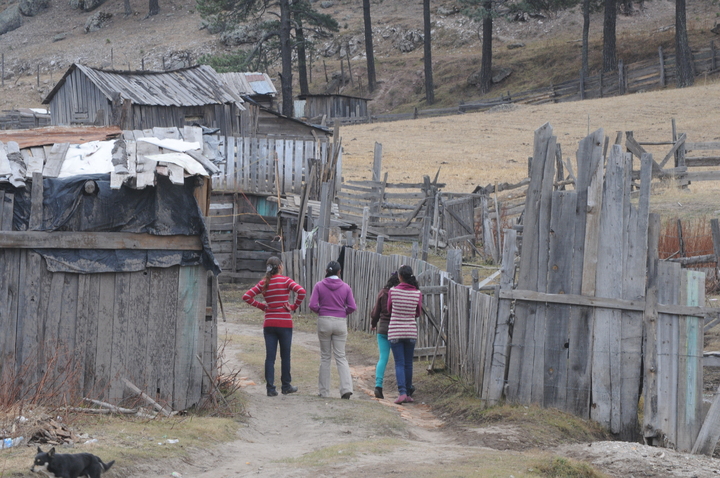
0 231 202 251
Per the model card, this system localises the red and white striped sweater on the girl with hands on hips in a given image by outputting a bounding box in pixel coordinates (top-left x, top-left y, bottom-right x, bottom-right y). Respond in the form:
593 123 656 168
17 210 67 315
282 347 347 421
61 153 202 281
243 274 306 328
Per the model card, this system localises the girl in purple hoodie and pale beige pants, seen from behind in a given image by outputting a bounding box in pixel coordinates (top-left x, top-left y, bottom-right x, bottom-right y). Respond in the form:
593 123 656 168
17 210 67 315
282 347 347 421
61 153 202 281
310 261 357 399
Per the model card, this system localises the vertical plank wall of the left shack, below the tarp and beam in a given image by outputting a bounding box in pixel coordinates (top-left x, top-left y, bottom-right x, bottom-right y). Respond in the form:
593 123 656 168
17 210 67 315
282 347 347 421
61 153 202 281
0 249 217 410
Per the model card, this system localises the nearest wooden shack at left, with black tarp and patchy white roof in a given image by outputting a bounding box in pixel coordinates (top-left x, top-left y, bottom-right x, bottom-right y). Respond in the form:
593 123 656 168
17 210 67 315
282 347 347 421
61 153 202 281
0 124 219 410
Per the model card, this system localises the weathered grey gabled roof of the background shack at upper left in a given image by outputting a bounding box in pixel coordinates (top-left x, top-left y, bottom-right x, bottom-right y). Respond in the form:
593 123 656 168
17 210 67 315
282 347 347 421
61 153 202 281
43 63 248 106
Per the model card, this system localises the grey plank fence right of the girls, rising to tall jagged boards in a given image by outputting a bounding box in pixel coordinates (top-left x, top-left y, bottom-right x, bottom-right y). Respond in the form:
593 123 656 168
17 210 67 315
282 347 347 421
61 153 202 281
284 124 718 452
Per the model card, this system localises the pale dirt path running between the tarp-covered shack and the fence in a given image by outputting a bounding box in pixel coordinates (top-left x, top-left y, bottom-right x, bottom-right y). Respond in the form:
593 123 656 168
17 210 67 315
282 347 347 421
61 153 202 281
141 322 469 478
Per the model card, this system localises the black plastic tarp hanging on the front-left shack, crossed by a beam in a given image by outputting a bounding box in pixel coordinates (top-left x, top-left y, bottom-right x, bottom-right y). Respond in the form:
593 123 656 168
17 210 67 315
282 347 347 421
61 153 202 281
0 174 220 275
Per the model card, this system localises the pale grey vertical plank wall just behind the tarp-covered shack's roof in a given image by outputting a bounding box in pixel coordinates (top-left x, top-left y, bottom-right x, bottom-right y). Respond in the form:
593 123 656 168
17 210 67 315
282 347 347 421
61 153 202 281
213 136 342 195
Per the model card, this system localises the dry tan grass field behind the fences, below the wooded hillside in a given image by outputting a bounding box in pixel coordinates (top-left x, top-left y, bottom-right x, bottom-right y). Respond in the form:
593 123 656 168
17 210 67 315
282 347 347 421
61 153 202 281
341 79 720 209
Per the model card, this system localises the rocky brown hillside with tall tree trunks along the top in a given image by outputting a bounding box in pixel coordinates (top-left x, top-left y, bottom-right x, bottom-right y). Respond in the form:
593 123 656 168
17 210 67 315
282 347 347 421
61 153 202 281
0 0 720 114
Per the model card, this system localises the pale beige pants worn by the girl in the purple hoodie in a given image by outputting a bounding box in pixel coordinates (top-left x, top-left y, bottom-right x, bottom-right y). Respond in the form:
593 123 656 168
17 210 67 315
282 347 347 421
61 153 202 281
318 315 353 397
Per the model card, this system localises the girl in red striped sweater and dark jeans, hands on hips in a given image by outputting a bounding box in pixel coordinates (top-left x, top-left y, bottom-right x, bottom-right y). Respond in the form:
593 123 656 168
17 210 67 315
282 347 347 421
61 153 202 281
243 257 306 397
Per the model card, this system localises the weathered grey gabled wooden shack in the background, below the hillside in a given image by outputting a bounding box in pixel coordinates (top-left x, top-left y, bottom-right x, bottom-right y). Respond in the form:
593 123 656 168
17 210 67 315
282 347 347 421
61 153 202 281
43 63 244 136
